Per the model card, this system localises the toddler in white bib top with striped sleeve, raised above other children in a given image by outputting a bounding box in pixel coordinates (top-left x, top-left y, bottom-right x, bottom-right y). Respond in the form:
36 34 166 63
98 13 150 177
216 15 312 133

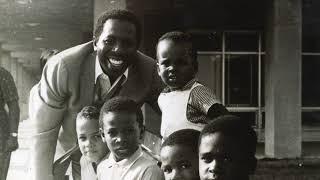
157 32 228 139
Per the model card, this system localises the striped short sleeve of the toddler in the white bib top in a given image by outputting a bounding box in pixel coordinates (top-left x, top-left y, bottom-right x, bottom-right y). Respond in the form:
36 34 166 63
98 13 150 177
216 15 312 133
188 85 221 115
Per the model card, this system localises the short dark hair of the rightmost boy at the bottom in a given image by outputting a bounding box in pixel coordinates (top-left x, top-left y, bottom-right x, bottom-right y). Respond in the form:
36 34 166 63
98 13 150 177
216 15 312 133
199 115 257 157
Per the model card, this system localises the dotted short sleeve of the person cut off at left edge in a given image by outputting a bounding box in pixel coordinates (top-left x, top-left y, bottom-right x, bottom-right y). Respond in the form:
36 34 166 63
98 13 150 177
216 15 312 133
1 71 19 102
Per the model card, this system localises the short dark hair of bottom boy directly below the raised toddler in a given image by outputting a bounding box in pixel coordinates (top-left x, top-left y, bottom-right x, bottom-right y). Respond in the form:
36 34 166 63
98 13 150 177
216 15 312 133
161 129 200 153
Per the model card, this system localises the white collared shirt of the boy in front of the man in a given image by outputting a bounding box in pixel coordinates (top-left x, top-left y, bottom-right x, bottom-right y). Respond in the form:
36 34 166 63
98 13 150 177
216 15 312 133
97 147 164 180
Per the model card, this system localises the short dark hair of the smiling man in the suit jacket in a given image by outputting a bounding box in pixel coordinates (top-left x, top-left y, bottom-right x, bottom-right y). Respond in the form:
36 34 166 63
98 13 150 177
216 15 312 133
94 9 142 47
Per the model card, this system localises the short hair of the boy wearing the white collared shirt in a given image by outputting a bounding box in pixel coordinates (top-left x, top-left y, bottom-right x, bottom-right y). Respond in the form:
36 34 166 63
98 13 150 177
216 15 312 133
99 96 143 129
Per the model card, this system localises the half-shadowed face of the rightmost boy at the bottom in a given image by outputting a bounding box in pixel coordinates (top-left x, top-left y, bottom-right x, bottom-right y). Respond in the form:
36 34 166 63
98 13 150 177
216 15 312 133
199 132 255 180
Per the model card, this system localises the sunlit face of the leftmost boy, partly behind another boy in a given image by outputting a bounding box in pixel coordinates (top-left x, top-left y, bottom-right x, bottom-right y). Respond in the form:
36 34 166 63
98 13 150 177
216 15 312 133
76 118 109 163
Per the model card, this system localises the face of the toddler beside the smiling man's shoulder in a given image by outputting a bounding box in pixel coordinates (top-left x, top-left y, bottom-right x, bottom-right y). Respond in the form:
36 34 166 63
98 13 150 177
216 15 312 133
157 40 196 88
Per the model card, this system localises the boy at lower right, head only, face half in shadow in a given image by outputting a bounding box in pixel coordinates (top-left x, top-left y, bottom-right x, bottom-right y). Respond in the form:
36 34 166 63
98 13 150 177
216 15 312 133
199 115 257 180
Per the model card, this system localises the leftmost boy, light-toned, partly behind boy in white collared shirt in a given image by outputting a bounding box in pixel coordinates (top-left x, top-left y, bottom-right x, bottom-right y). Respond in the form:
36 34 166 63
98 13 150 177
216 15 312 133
76 106 109 180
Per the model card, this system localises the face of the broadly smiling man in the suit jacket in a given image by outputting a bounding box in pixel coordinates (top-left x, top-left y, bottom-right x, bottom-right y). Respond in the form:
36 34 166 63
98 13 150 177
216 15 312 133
94 19 138 77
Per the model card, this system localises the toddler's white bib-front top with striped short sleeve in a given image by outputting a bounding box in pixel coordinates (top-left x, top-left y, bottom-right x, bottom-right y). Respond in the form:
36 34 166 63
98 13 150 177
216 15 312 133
158 79 220 139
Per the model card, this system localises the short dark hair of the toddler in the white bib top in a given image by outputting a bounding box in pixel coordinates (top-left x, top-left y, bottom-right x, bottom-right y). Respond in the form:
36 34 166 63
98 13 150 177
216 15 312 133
156 31 198 71
